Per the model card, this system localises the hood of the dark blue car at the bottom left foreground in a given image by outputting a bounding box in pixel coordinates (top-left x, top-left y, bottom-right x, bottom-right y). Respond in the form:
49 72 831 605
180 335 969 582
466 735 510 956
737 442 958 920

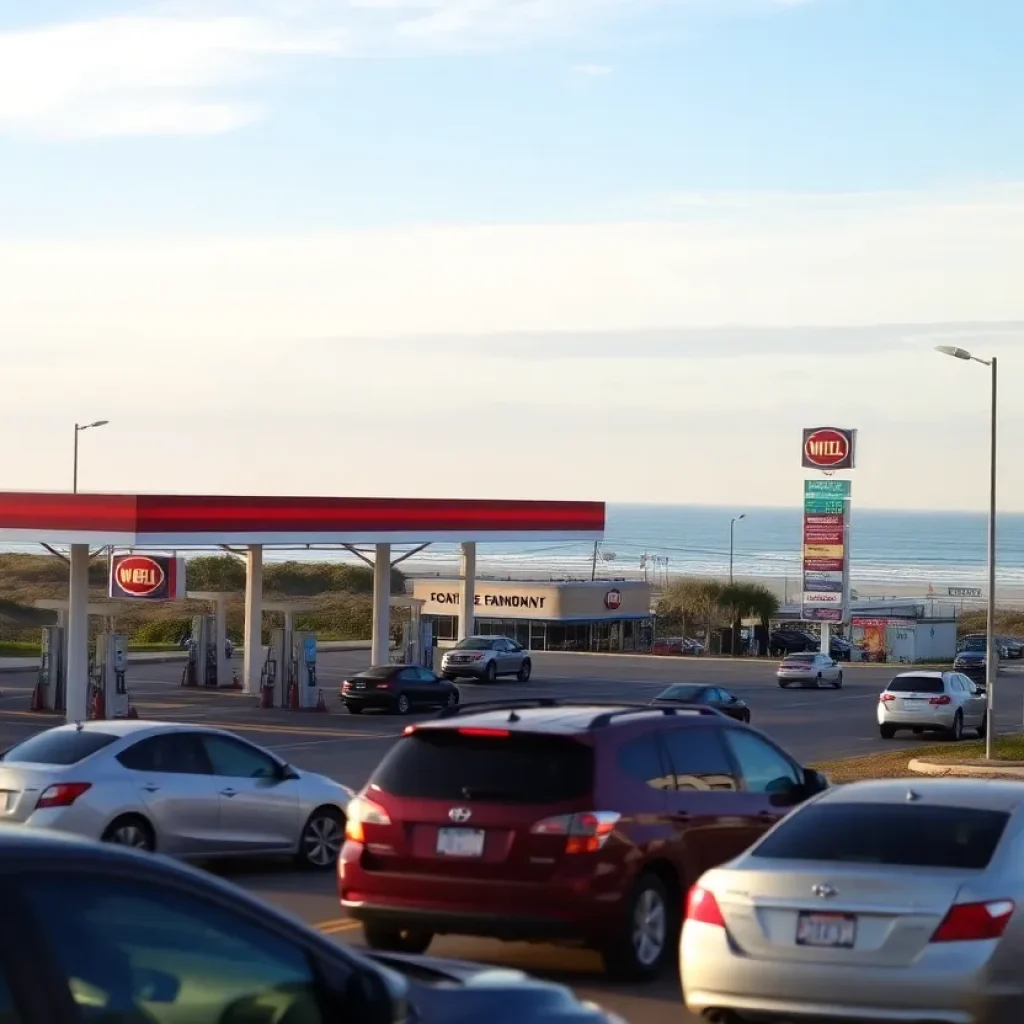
360 950 625 1024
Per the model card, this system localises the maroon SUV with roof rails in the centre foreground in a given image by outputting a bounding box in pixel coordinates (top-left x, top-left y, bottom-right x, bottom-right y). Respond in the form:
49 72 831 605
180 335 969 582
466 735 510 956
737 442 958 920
338 698 828 981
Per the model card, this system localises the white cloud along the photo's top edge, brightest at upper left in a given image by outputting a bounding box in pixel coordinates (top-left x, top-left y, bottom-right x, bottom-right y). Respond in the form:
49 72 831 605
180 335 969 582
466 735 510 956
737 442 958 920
0 0 811 138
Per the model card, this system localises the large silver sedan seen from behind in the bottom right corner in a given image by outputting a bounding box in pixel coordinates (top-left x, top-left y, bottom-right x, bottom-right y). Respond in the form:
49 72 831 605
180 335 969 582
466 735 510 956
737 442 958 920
680 778 1024 1024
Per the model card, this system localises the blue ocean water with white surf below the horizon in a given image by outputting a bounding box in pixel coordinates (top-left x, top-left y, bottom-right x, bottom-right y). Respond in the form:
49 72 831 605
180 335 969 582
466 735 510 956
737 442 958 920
2 503 1024 594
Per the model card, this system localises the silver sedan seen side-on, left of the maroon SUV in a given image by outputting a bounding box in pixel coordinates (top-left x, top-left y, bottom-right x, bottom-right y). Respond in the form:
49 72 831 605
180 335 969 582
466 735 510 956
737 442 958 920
0 721 353 870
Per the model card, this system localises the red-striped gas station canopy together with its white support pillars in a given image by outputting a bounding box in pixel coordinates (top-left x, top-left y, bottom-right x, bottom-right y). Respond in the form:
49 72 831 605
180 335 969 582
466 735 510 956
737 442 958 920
0 490 604 722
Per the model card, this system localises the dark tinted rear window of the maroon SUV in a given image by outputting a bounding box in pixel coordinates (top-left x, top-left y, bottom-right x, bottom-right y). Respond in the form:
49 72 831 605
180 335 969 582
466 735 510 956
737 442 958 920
370 729 594 804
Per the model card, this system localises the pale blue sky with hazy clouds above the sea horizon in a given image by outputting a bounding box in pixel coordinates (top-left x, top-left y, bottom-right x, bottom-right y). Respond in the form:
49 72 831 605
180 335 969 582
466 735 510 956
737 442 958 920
0 0 1024 511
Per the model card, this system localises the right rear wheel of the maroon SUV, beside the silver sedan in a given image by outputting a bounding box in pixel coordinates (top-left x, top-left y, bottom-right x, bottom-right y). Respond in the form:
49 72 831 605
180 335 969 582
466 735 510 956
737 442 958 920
601 874 678 982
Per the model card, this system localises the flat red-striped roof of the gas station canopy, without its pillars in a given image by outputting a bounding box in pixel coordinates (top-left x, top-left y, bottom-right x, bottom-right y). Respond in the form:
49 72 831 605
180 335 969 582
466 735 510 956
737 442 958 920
0 492 604 548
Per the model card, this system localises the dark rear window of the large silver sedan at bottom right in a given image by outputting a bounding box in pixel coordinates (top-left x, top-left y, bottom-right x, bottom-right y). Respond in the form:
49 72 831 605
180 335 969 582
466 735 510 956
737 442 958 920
751 803 1010 869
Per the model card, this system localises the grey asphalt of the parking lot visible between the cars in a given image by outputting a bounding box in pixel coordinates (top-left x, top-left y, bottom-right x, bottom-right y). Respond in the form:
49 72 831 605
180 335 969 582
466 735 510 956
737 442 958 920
0 651 1024 1024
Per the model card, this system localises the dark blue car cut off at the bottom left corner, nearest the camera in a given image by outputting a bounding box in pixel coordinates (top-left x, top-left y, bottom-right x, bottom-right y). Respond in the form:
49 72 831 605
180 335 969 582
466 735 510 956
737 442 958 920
0 826 616 1024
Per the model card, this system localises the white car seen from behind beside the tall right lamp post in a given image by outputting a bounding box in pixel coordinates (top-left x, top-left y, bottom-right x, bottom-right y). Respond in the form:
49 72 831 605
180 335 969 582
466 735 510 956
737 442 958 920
878 672 988 739
